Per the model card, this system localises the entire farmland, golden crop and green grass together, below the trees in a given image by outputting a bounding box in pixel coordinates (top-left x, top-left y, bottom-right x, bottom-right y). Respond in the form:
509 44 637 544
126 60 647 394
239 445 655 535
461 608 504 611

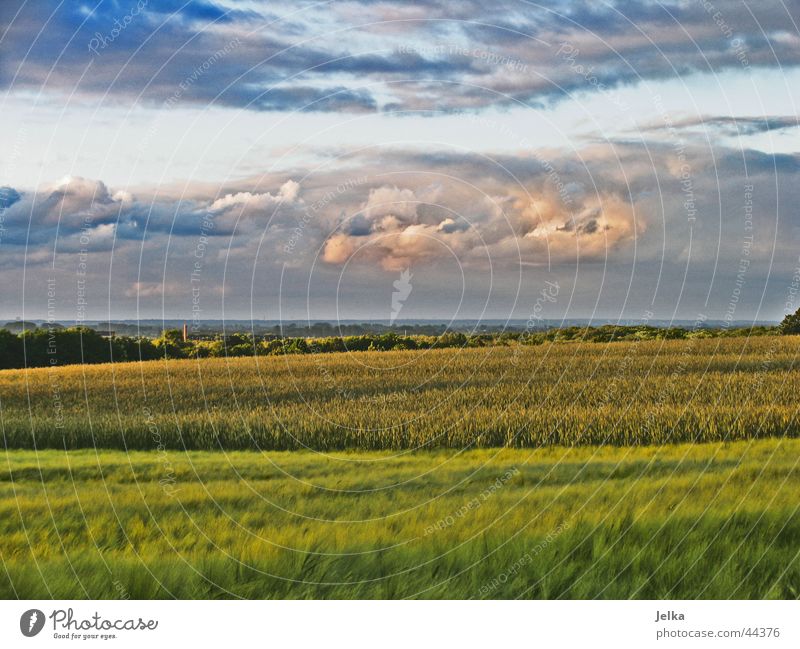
0 336 800 598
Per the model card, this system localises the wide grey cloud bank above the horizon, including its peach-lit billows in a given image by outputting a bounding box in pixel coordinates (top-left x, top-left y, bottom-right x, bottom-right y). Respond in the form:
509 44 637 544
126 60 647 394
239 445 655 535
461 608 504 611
0 139 800 319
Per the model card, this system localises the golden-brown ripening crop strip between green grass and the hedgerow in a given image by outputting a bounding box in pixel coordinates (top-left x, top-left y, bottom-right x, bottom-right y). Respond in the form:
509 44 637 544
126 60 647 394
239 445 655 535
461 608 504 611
0 336 800 450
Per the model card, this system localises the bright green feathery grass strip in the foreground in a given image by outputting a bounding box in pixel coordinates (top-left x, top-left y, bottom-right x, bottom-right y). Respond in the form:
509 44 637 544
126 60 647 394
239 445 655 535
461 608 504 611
0 439 800 598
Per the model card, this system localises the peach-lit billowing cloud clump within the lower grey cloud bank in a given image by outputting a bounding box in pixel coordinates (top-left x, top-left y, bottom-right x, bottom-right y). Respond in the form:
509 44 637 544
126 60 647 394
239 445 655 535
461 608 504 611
322 165 646 270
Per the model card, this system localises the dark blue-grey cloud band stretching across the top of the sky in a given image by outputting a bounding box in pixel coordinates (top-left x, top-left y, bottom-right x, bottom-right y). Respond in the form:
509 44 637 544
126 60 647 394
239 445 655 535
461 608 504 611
0 0 800 112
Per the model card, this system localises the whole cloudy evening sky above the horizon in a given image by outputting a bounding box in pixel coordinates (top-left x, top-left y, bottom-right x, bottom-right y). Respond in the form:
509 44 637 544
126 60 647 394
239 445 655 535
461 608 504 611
0 0 800 323
